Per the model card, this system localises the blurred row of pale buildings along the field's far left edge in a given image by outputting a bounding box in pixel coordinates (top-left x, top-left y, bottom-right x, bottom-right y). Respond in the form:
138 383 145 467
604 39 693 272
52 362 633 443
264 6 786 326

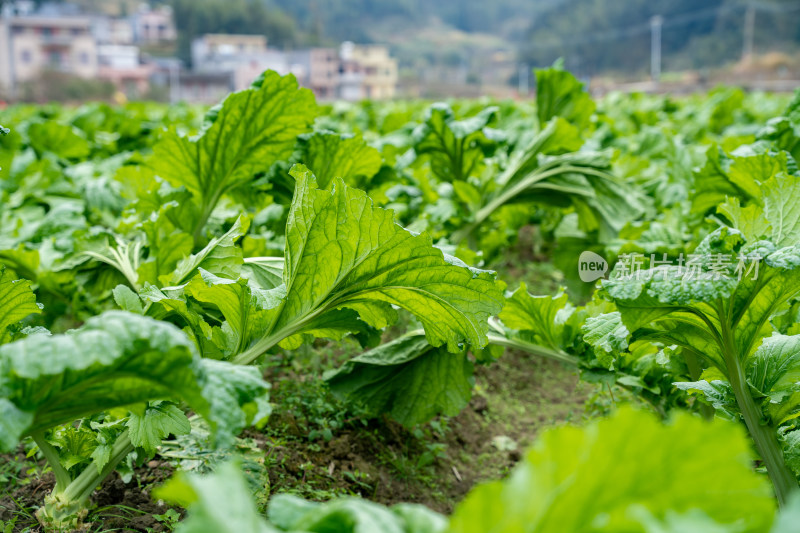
0 0 398 103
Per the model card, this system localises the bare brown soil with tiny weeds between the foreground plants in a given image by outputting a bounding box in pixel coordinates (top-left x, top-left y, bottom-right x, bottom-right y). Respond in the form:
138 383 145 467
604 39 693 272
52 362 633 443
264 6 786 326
0 351 597 532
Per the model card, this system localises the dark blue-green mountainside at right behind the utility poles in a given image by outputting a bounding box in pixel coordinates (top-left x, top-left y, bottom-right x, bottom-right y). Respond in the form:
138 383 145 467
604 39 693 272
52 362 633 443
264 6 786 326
518 0 800 75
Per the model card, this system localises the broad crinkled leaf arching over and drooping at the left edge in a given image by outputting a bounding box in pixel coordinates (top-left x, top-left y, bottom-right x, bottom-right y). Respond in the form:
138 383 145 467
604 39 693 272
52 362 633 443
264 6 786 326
0 311 268 449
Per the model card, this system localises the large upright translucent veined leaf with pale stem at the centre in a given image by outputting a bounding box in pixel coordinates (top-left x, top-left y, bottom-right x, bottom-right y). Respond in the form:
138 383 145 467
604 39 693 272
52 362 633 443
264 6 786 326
231 166 502 363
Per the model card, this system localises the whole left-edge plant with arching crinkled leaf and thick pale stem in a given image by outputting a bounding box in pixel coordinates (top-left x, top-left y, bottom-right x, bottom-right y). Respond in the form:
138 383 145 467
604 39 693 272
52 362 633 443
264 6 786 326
0 311 269 528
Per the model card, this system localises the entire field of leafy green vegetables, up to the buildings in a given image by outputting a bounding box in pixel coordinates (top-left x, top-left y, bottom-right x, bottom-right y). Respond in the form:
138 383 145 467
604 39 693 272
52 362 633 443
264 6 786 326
0 65 800 533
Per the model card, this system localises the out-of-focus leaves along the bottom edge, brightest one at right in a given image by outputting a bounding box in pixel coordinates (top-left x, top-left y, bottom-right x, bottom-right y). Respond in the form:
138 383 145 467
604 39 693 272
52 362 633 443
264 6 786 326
161 408 780 533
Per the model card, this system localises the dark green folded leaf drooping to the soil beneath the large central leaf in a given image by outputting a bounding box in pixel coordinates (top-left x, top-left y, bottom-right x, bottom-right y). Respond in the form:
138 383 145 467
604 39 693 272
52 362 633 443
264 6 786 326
325 335 473 427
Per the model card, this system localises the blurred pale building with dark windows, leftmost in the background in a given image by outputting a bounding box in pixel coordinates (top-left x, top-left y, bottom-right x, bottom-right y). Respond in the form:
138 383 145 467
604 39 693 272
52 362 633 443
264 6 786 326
0 13 98 92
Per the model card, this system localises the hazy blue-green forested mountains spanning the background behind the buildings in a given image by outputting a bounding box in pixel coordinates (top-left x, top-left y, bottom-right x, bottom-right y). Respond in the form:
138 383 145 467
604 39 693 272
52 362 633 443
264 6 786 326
159 0 800 77
